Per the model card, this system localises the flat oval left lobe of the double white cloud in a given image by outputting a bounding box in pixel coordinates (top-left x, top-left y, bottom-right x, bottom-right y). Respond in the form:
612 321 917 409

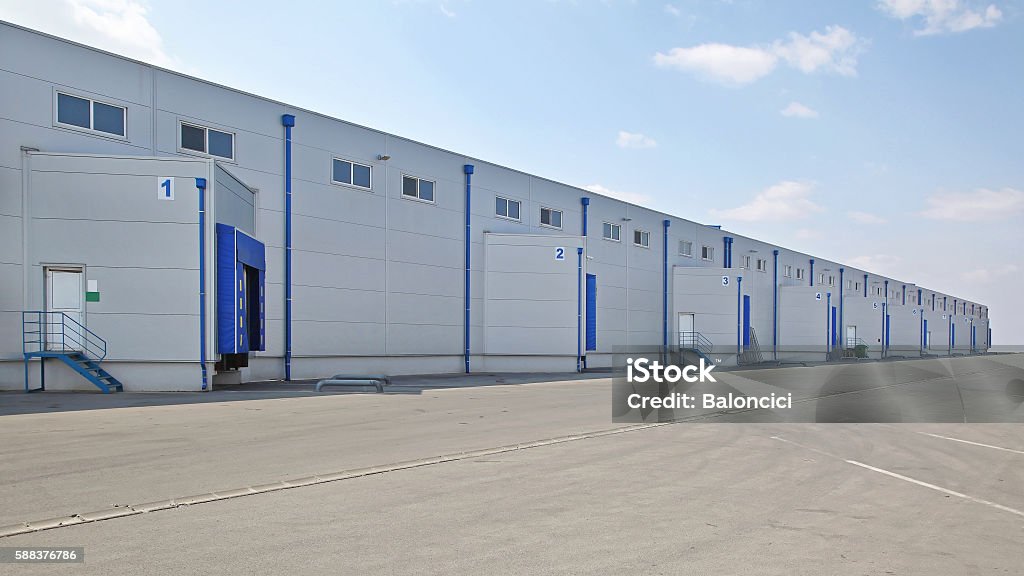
654 43 778 84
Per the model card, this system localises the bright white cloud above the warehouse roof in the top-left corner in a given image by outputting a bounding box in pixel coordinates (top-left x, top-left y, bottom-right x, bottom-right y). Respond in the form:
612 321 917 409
3 0 182 70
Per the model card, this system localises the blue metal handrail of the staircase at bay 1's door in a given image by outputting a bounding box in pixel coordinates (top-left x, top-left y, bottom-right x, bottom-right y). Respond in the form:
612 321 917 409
22 311 106 362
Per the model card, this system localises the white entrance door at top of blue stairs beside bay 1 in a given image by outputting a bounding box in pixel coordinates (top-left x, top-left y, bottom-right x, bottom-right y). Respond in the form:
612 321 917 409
46 268 85 349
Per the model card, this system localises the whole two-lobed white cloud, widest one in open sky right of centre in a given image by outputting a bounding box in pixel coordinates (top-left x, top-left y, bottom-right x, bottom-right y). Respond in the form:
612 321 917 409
654 26 865 85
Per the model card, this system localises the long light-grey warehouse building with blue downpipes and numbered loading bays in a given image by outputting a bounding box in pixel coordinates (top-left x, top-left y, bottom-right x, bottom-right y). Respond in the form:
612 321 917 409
0 23 991 392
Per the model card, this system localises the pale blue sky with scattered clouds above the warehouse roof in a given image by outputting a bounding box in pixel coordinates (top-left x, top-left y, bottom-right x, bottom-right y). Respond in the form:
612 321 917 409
6 0 1024 344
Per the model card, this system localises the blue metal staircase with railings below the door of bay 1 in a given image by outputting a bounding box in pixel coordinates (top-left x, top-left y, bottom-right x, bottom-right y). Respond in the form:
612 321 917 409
22 311 124 394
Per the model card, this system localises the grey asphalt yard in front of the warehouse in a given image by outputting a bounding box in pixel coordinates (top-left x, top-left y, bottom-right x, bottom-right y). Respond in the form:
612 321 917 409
0 352 1024 575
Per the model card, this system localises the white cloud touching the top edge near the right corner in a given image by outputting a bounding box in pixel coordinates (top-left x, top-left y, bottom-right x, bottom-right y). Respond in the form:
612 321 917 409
878 0 1002 36
